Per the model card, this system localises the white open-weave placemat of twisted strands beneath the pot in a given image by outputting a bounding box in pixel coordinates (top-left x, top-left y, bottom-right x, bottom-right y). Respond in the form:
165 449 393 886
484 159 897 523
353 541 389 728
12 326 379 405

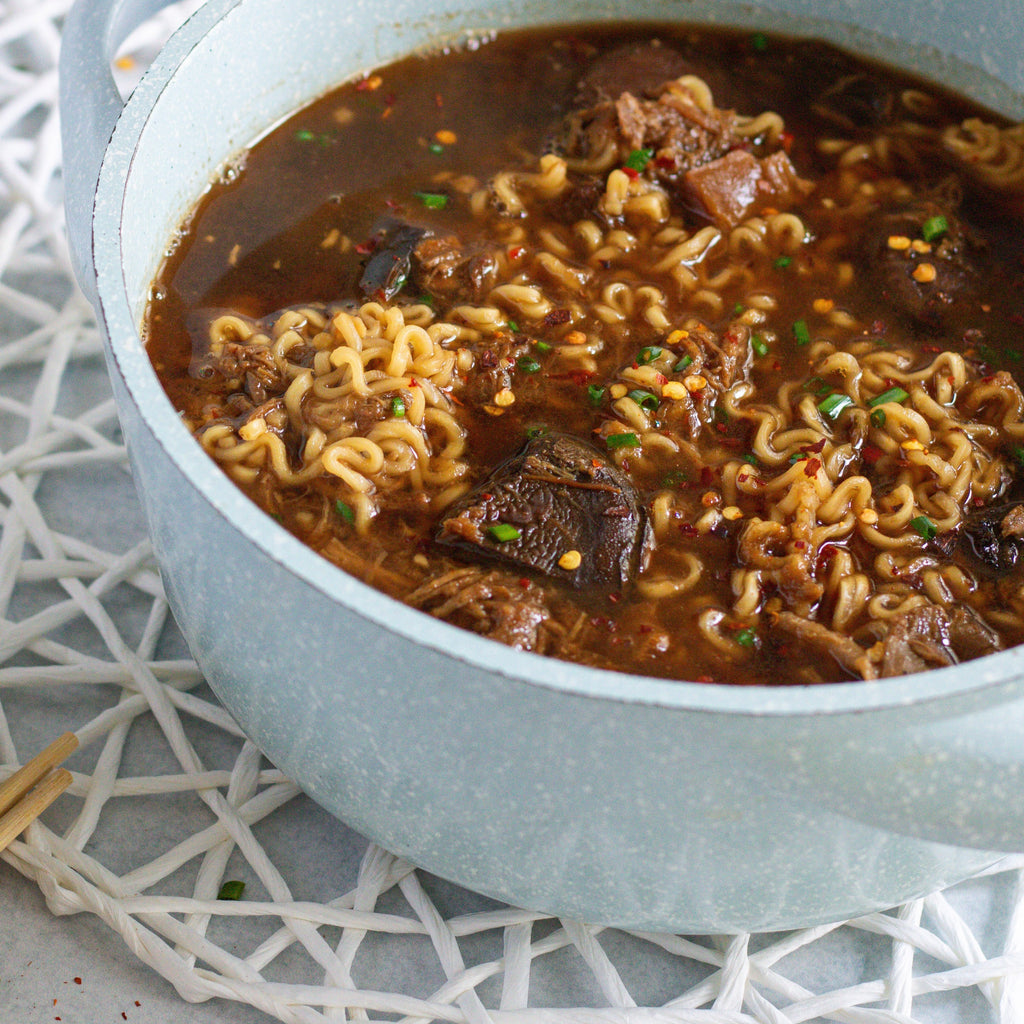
6 0 1024 1024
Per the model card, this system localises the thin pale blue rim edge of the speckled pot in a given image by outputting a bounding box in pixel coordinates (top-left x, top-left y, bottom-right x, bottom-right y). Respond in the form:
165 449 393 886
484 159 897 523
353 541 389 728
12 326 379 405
91 0 1024 717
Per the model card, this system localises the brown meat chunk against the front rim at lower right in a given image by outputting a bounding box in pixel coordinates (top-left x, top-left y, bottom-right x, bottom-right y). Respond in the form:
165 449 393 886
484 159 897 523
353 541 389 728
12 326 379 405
882 604 1002 676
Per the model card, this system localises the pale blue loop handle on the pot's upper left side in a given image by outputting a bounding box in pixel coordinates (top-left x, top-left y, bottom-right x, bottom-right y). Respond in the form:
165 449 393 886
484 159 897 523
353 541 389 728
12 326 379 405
59 0 182 305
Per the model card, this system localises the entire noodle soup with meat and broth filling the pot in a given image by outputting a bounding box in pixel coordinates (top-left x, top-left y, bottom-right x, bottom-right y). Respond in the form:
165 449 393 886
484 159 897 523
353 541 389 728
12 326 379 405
145 25 1024 685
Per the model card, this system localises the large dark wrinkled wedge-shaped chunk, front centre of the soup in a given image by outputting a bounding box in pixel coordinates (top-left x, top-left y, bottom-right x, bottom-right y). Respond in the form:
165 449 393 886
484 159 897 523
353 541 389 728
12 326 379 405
436 434 653 590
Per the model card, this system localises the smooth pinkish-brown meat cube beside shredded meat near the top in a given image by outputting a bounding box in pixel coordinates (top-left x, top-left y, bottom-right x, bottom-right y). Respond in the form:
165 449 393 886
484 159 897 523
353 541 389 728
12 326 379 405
684 150 814 228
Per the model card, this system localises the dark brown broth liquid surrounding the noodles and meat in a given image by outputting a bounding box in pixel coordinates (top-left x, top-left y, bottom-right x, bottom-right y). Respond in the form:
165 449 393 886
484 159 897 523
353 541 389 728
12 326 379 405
145 25 1024 684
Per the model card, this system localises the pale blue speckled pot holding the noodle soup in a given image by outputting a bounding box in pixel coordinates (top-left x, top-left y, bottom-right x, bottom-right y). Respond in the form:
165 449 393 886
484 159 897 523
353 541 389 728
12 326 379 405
61 0 1024 932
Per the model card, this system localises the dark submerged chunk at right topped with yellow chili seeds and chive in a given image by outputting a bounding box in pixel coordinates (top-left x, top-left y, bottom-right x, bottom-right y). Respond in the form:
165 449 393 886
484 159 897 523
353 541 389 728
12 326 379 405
860 202 979 331
